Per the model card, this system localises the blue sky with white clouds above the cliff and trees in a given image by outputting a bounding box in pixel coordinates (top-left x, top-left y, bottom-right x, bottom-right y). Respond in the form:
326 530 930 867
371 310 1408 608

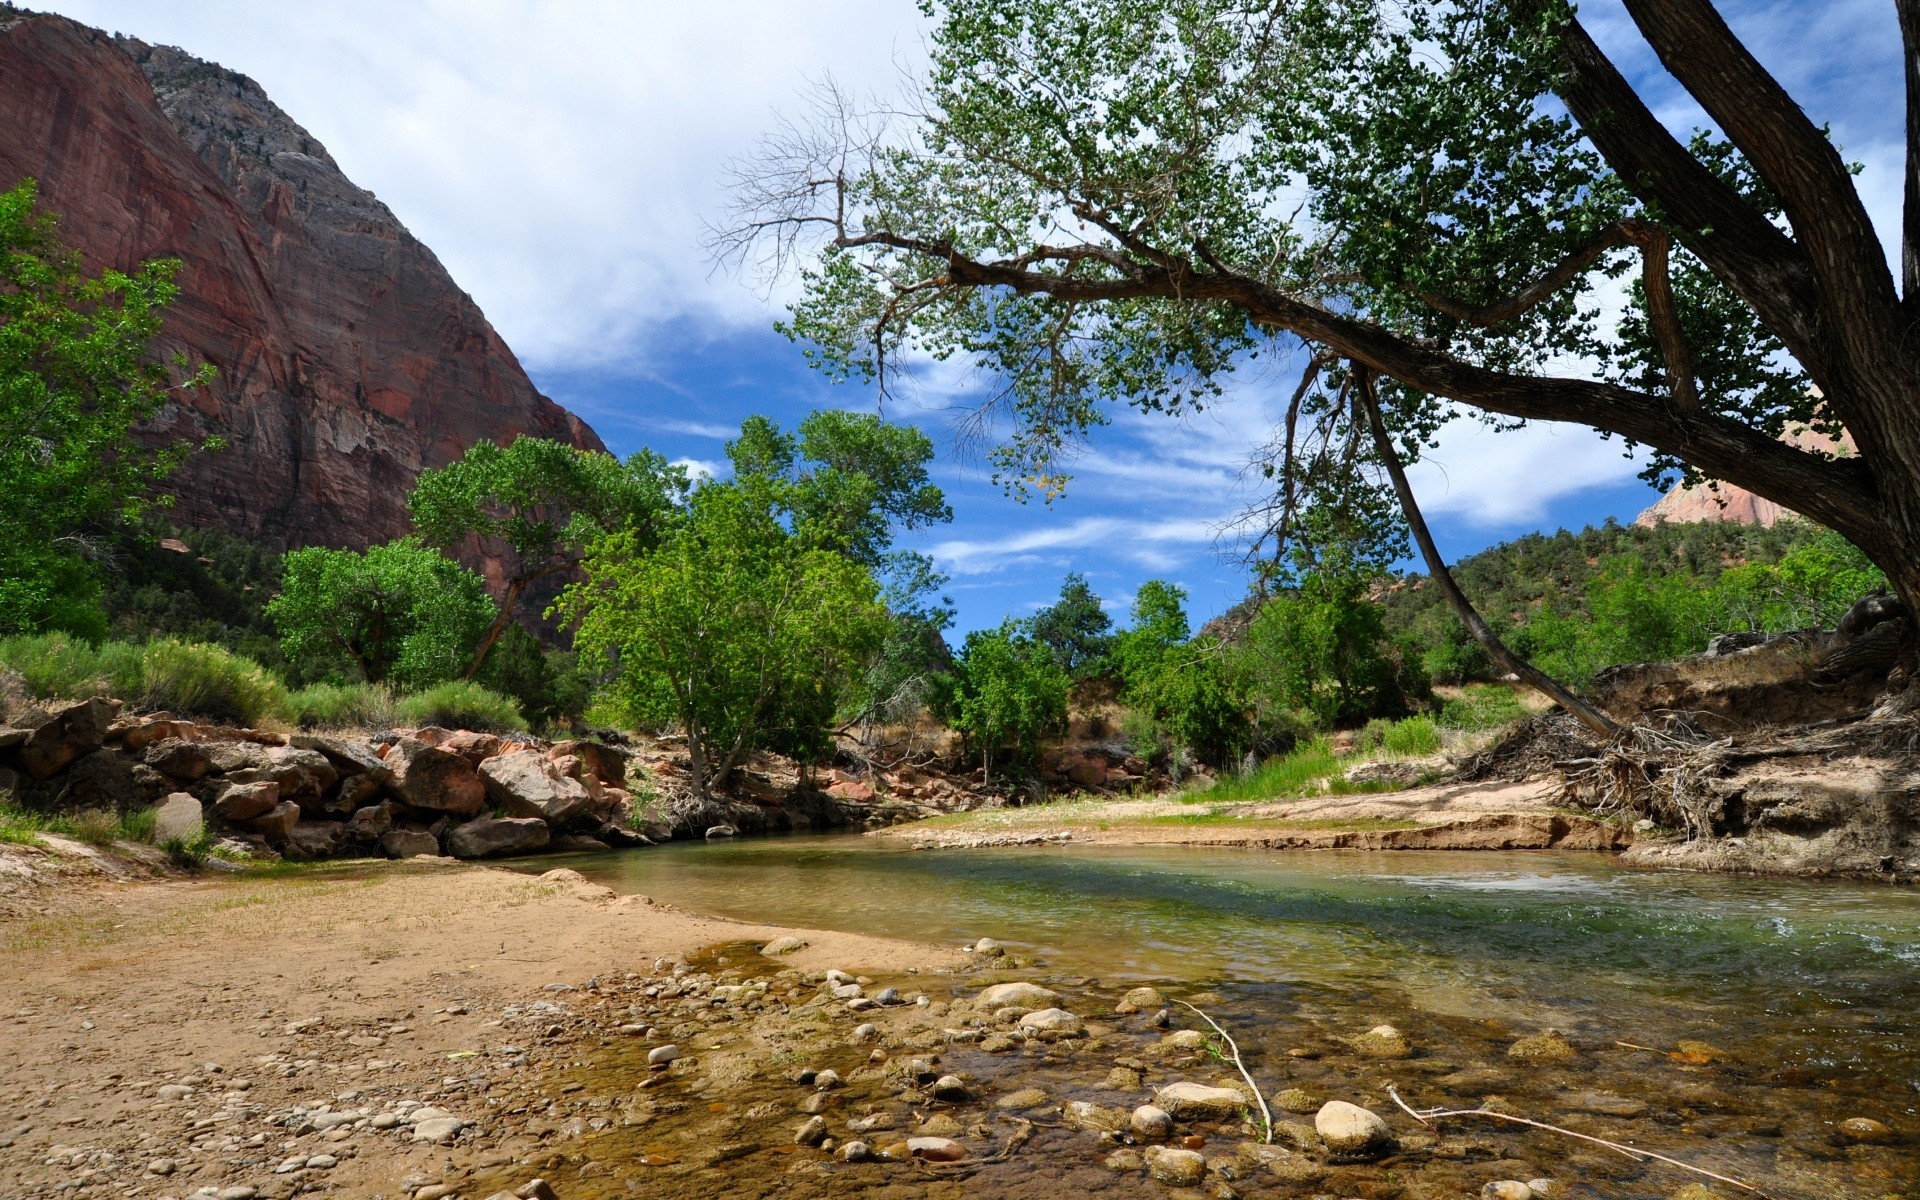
31 0 1903 628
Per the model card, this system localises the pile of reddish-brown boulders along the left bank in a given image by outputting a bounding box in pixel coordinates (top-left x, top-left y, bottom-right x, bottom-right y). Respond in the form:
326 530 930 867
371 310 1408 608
0 699 672 858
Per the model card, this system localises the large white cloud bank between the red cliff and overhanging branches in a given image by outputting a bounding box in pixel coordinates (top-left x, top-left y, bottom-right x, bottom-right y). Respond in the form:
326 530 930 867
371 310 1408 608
42 0 922 369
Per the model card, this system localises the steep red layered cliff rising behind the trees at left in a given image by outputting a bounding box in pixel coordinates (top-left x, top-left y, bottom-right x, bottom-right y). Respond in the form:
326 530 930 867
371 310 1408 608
0 8 603 547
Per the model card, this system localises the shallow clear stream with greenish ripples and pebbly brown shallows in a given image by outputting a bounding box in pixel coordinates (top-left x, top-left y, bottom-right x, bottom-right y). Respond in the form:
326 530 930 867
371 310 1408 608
499 837 1920 1200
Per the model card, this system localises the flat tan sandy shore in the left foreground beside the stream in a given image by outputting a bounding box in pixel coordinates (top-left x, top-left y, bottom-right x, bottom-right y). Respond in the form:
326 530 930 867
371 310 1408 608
0 847 958 1200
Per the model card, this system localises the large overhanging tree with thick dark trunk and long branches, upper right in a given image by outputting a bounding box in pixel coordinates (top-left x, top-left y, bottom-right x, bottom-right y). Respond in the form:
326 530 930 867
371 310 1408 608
714 0 1920 656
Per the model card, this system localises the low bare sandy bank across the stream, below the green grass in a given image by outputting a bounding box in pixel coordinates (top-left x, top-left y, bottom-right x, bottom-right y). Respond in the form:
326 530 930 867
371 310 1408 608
870 780 1634 852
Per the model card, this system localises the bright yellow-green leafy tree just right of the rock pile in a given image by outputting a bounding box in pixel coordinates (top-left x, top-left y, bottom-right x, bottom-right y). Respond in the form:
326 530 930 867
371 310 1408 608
557 474 889 795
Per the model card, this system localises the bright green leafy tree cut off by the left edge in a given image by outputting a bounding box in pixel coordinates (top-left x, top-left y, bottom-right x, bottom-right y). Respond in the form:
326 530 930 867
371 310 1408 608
0 180 217 637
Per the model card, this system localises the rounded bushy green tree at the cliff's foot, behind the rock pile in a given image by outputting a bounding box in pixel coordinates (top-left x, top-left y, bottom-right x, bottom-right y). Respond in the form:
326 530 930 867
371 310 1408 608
267 538 495 687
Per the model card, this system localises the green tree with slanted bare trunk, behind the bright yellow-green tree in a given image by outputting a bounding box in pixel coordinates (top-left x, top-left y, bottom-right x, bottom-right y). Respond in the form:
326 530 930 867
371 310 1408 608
407 436 687 680
